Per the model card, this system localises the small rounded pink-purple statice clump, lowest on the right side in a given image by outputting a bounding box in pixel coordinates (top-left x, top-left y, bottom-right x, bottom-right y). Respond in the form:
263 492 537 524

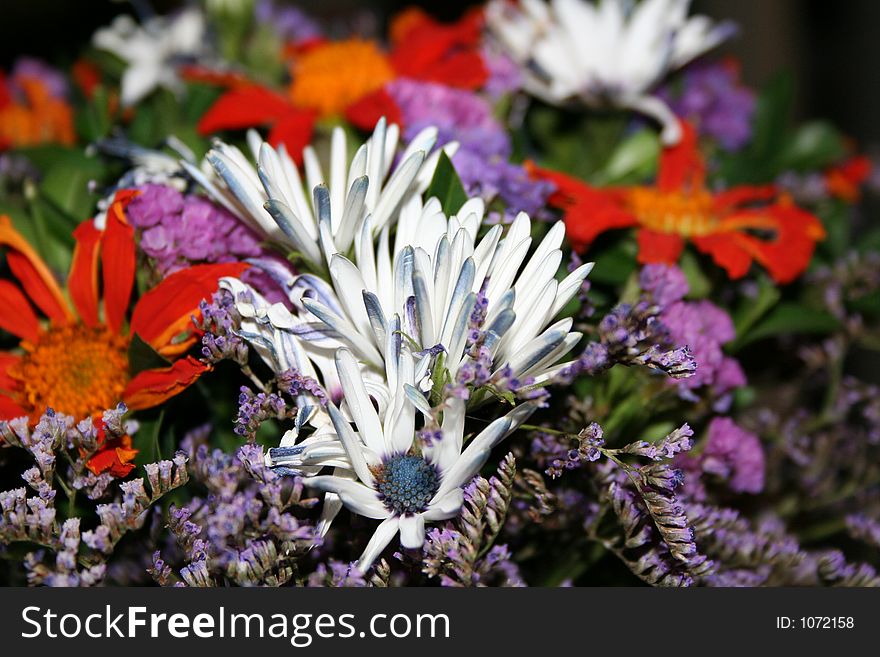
699 417 764 493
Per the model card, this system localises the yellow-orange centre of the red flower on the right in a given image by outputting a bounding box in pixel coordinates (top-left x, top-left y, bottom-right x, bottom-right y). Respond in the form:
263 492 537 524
627 187 717 237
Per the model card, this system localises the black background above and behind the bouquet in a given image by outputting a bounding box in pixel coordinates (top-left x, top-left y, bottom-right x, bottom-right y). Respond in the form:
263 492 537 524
0 0 880 152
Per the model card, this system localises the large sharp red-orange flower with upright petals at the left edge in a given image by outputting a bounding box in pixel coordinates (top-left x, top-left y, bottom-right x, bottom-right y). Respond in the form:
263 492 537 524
0 191 247 472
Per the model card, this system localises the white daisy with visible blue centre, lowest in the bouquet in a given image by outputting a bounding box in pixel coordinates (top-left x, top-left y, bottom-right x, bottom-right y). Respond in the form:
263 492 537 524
273 348 536 572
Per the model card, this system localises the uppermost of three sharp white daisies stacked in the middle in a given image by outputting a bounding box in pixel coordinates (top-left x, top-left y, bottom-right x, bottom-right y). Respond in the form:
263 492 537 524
184 119 455 267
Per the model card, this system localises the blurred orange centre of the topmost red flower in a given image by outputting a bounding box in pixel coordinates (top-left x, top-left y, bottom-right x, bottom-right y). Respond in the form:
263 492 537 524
290 39 394 116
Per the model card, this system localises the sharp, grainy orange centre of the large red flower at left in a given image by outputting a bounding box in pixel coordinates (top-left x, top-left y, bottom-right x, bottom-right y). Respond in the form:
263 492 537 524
9 324 128 418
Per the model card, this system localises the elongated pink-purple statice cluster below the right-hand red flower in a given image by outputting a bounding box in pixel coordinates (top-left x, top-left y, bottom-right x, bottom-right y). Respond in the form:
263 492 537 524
639 265 746 400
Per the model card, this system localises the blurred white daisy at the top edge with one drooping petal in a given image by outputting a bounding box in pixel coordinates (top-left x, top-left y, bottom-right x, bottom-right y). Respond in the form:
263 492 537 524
486 0 735 144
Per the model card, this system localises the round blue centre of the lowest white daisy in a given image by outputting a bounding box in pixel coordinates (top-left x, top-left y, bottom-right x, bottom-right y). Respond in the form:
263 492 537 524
373 454 440 515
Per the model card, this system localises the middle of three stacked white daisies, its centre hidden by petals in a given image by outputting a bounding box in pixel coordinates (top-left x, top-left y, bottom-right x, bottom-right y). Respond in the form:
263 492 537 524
292 196 593 388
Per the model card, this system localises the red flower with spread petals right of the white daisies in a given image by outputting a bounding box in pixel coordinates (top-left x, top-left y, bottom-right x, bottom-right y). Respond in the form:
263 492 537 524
532 124 825 283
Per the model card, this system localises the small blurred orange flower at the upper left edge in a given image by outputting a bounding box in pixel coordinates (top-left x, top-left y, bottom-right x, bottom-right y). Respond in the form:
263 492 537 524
0 72 75 149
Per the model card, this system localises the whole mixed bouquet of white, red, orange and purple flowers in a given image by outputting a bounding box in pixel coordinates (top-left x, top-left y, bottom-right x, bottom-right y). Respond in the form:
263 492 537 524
0 0 880 587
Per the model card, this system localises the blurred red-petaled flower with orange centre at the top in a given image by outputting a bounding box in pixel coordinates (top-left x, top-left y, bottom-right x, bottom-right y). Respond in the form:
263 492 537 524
188 9 488 158
